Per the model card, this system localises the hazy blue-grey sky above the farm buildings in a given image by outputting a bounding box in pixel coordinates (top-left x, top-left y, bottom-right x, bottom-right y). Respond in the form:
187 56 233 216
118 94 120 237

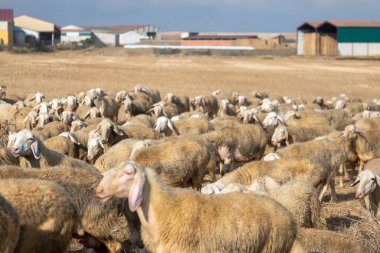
0 0 380 32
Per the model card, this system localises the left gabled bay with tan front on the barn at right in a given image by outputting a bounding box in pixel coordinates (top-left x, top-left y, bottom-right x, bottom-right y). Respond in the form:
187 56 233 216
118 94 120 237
297 21 322 55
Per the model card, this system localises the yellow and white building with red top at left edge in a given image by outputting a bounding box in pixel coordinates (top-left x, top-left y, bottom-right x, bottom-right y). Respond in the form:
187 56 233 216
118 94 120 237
0 9 13 47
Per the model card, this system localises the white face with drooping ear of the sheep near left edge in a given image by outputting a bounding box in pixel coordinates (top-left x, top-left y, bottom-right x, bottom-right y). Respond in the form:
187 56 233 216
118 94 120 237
11 129 40 159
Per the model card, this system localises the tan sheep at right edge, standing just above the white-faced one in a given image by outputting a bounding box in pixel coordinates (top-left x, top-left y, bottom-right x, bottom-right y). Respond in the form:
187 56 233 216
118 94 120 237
342 125 380 172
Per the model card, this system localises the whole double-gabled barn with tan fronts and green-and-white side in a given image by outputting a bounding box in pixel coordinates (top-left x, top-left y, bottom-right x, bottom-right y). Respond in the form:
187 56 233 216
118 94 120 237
297 20 380 56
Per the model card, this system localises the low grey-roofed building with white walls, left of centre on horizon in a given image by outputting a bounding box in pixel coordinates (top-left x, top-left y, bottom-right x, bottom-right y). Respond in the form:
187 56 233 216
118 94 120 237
87 25 161 46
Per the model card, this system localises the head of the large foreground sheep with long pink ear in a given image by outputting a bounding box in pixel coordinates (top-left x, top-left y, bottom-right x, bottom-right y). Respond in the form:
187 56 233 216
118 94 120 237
96 161 146 212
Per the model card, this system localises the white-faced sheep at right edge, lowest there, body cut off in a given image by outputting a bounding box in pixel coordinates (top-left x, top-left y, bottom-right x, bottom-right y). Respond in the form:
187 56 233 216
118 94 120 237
352 168 380 221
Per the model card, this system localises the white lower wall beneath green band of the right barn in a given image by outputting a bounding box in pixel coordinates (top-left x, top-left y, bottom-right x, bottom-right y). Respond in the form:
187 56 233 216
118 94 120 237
338 43 380 56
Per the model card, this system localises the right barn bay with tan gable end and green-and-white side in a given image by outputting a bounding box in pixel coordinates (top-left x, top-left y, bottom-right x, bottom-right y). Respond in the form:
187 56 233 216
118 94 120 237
318 20 380 56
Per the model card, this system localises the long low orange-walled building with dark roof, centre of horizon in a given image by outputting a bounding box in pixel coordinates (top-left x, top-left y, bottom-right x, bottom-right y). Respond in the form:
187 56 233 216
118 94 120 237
181 35 258 46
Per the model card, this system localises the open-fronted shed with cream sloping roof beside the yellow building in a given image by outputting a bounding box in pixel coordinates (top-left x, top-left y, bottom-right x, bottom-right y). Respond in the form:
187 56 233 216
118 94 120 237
14 15 60 46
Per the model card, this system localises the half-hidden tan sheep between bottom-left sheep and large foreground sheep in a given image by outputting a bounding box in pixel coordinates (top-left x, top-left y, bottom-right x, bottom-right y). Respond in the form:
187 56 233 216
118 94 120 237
0 166 126 252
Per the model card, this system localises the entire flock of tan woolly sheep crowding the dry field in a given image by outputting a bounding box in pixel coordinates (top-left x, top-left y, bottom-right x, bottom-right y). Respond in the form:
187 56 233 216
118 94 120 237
0 86 380 253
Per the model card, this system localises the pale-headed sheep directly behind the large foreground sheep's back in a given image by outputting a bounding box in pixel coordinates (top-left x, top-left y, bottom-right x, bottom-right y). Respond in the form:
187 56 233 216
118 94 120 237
215 176 326 229
